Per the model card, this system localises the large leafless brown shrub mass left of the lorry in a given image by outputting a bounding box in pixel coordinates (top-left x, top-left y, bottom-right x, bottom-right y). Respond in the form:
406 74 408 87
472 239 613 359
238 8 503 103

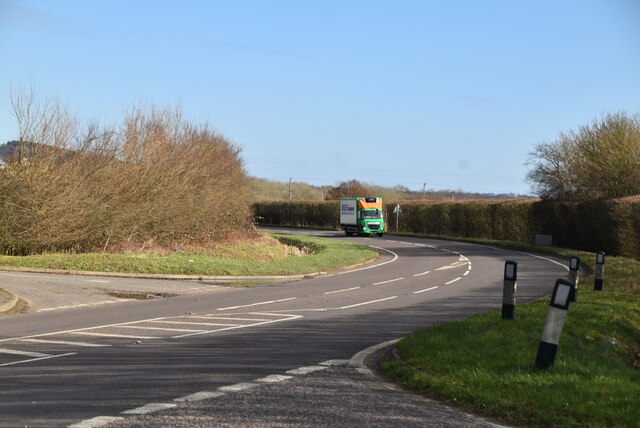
0 88 250 254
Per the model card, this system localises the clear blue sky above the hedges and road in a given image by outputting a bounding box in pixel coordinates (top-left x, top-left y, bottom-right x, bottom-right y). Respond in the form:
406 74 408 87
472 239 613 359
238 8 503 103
0 0 640 193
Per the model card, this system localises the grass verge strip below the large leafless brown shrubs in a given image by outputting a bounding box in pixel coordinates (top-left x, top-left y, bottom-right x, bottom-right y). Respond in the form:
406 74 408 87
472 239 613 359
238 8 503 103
0 234 378 276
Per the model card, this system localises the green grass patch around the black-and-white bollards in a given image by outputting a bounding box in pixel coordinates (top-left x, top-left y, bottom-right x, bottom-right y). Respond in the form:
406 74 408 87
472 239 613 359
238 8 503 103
381 239 640 426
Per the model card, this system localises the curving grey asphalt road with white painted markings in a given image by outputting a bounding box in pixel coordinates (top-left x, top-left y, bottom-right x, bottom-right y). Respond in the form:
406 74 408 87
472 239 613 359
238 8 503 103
0 230 567 427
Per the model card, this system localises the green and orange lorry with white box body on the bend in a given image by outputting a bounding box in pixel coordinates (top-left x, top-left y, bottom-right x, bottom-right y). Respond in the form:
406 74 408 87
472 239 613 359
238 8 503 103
340 198 384 236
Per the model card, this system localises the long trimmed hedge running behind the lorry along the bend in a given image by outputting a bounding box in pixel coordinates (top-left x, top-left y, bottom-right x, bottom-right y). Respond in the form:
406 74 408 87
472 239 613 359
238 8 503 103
253 196 640 260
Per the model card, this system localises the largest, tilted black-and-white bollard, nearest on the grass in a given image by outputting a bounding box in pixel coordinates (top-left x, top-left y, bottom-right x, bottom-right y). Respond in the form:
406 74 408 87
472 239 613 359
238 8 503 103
536 279 574 369
